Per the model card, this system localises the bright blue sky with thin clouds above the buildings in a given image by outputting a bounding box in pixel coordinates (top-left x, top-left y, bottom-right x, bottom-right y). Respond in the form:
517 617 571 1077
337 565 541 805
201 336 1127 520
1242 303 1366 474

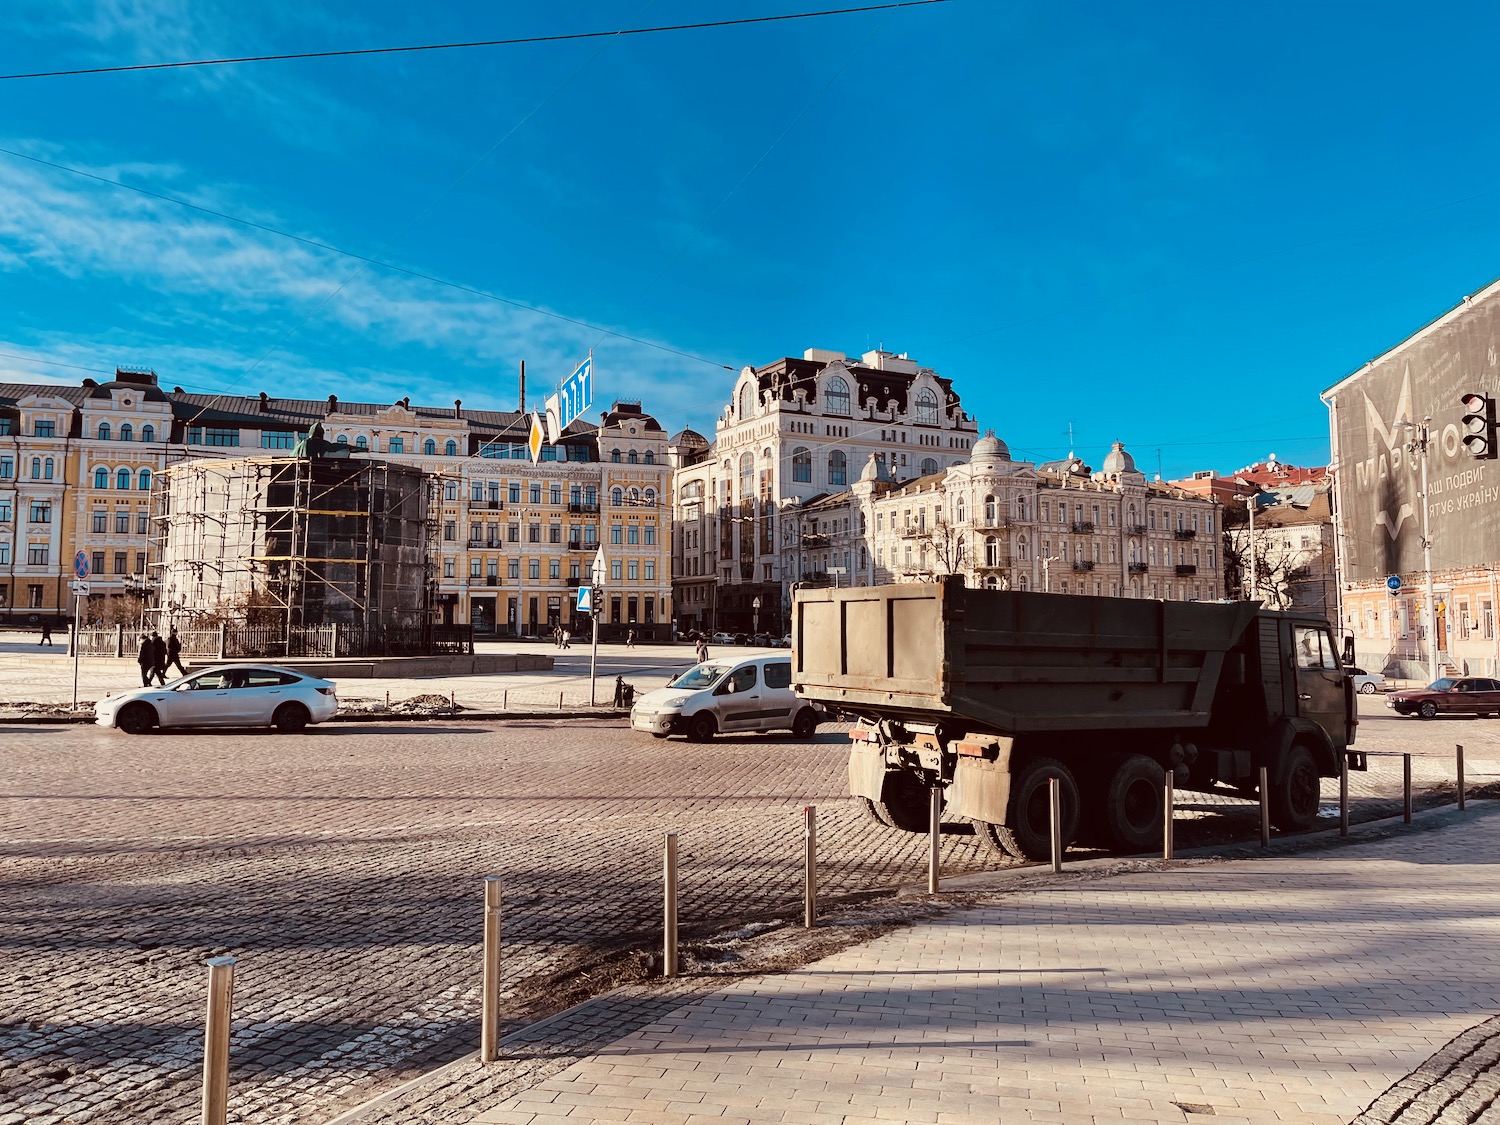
0 0 1500 477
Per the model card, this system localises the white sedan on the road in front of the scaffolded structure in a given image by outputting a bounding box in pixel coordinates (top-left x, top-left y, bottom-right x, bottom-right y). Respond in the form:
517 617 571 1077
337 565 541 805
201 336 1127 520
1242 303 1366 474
95 665 339 735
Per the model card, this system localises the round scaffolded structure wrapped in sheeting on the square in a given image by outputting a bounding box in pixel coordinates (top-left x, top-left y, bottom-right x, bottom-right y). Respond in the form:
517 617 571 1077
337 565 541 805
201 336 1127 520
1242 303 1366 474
152 456 446 656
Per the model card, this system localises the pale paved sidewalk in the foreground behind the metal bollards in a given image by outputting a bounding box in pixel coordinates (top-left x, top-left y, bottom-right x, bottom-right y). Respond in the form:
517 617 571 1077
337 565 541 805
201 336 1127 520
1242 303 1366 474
453 803 1500 1125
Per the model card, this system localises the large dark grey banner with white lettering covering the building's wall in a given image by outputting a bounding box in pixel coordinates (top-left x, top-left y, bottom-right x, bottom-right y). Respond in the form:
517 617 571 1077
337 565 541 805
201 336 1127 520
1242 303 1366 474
1325 291 1500 582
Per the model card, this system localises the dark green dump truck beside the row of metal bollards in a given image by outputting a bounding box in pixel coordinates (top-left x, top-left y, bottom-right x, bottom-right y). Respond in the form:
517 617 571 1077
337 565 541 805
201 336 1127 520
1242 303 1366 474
792 578 1364 860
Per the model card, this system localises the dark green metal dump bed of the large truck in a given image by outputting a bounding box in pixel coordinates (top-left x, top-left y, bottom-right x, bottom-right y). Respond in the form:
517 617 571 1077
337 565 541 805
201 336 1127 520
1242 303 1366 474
792 579 1259 734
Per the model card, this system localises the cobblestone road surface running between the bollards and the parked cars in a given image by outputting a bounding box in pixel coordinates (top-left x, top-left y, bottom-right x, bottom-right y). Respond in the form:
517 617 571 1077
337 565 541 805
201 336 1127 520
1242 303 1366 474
0 696 1488 1125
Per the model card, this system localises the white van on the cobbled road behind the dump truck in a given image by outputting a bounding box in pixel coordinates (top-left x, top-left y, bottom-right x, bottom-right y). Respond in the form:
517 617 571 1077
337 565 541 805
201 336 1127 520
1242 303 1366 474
630 656 827 743
